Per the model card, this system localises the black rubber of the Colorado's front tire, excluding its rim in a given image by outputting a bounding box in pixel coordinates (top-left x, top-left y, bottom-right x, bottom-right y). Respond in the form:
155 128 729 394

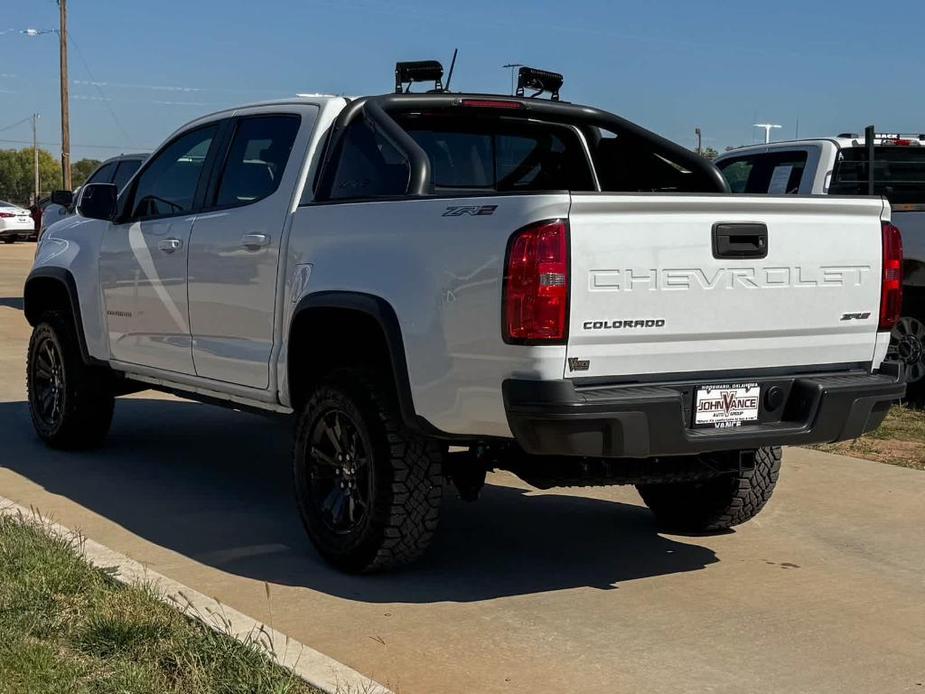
26 311 115 450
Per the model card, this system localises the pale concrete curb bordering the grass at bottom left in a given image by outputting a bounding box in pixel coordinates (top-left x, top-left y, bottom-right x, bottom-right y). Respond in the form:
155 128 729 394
0 496 392 694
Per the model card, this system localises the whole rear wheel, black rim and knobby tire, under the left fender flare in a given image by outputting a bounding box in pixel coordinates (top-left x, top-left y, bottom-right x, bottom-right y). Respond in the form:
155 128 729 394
293 369 446 573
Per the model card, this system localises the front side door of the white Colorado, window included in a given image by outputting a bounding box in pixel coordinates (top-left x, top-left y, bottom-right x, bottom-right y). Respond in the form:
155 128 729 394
99 123 219 374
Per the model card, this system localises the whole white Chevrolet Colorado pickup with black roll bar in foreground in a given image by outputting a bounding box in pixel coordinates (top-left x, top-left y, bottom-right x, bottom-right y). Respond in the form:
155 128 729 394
24 64 904 571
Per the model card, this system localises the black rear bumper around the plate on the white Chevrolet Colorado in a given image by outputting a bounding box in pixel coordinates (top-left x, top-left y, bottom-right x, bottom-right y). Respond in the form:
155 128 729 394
503 372 906 458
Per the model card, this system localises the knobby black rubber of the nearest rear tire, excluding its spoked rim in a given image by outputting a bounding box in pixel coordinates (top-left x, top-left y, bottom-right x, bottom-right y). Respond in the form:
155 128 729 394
294 370 446 573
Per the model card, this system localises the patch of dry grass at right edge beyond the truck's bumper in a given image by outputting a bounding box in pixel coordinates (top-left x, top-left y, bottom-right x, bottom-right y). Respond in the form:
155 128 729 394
816 406 925 470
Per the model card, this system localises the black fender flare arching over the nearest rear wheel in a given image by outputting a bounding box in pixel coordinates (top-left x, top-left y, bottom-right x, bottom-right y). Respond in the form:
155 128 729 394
286 291 437 434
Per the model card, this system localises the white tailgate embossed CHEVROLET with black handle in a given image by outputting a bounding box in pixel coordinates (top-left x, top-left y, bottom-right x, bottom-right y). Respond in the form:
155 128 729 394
565 193 883 381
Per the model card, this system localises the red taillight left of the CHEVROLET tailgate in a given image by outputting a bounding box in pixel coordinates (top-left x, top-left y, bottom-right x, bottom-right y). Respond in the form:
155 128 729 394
503 219 569 344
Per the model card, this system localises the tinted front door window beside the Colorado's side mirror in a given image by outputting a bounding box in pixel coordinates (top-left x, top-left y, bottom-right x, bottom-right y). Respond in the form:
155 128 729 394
131 124 218 219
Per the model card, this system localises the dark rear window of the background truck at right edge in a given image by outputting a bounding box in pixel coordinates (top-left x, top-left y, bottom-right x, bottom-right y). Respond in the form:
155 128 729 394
829 145 925 204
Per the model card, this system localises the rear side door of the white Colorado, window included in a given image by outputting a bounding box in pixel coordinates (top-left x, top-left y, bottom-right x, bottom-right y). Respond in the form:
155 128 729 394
189 107 308 389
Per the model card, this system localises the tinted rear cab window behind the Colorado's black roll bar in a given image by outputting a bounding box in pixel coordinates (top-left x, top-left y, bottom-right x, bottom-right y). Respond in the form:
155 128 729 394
402 117 594 192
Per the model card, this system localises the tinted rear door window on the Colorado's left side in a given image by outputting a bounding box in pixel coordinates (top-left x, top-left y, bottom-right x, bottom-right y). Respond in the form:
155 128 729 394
213 115 301 207
